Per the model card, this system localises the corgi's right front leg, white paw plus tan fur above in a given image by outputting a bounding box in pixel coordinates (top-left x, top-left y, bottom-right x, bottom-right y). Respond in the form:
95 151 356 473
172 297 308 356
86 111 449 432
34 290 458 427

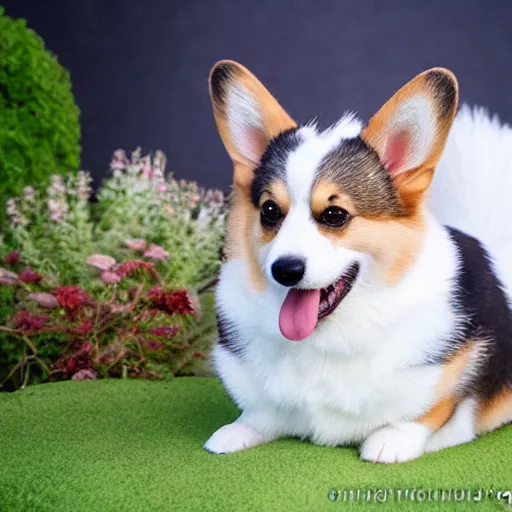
360 396 457 464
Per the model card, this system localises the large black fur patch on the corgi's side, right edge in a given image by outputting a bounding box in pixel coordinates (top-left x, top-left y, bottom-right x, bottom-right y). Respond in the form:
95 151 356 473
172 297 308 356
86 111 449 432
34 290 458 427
447 228 512 398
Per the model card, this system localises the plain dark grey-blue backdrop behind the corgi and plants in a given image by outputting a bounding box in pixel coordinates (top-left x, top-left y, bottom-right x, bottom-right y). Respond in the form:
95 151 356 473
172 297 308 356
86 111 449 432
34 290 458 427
4 0 512 189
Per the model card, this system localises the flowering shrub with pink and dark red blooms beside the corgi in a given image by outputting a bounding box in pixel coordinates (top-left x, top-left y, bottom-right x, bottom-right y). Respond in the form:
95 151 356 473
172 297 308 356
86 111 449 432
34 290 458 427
0 150 225 387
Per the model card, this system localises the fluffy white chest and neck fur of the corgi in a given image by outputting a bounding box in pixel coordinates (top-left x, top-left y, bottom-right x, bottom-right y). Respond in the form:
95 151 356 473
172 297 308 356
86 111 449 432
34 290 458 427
214 222 456 445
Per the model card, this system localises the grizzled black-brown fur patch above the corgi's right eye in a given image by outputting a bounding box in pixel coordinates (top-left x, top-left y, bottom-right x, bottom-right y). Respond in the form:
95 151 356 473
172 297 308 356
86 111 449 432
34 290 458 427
313 137 406 217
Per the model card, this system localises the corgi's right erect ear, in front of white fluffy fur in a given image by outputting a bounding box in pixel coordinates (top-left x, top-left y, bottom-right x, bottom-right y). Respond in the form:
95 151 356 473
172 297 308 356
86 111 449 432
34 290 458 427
361 68 458 209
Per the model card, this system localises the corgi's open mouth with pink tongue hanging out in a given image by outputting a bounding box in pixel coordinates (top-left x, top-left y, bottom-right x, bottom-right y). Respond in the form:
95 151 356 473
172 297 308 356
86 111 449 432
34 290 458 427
279 263 359 341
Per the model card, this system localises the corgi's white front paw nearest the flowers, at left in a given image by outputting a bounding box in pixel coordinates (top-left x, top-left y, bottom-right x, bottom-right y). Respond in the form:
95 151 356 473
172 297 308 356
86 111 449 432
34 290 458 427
204 421 269 453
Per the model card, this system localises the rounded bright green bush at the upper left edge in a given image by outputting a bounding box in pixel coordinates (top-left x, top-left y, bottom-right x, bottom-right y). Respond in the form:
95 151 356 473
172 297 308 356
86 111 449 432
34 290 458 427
0 7 80 221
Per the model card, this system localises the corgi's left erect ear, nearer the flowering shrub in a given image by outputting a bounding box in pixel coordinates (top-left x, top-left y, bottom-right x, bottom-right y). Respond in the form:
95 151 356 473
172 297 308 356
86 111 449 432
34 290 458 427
209 60 297 186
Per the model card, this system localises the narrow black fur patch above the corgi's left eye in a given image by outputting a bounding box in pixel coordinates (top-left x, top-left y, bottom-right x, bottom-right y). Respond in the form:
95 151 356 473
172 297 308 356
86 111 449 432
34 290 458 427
251 128 301 207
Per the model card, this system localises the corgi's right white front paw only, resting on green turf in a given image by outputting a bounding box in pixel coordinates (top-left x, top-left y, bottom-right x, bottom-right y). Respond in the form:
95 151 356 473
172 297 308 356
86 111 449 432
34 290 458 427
360 423 431 464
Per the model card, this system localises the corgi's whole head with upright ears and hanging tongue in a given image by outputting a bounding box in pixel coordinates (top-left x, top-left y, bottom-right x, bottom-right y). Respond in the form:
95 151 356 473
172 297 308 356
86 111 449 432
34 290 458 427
210 61 458 340
